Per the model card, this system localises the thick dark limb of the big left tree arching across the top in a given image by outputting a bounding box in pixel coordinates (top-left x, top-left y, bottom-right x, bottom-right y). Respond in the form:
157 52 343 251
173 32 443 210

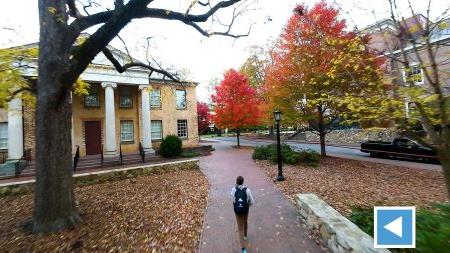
58 0 245 103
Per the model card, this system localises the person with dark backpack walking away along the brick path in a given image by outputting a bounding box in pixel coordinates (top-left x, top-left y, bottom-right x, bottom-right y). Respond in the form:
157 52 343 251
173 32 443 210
231 176 255 253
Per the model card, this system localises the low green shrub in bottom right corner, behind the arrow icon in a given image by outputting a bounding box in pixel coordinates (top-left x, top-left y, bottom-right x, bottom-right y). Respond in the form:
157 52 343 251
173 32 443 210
349 204 450 253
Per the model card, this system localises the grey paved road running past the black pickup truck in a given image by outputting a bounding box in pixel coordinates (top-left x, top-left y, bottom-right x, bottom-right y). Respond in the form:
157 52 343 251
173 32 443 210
210 137 441 170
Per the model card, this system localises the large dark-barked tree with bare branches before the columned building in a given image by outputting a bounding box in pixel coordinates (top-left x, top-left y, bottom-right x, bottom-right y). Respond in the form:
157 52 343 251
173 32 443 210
8 0 250 233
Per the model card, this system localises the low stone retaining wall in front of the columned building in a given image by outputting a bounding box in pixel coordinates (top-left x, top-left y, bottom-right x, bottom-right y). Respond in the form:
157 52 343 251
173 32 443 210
0 159 200 196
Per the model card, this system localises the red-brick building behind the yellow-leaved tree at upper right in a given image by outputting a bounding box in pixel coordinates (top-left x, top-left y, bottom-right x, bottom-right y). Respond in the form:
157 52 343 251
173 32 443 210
361 14 450 120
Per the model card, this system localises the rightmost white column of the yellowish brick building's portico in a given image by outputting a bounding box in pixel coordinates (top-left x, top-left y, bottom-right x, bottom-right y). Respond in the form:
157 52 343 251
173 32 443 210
139 85 155 154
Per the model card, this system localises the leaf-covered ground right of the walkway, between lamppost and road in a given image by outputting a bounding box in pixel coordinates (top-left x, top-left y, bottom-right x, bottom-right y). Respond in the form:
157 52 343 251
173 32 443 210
257 157 448 216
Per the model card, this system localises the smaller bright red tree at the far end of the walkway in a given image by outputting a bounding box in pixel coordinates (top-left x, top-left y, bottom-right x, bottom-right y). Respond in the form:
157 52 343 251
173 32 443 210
211 69 262 147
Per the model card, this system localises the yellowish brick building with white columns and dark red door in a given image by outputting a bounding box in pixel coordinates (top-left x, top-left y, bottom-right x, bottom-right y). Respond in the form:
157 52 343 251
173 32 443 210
0 44 199 160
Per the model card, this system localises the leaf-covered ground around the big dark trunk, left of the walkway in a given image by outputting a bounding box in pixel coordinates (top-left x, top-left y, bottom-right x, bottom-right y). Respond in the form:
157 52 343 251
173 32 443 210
0 170 208 252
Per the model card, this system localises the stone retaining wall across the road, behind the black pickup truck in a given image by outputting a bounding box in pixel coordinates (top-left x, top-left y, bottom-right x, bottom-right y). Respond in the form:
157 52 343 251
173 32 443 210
305 128 398 144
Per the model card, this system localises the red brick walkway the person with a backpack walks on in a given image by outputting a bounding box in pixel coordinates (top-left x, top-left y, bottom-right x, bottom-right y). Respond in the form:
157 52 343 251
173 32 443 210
199 142 323 253
